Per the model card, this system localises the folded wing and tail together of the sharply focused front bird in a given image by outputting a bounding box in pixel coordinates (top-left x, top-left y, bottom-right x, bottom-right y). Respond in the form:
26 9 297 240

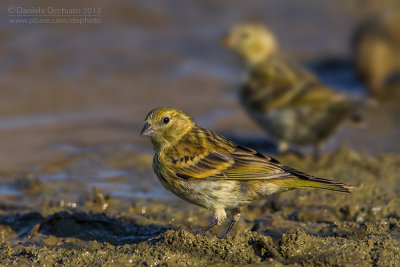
169 146 354 193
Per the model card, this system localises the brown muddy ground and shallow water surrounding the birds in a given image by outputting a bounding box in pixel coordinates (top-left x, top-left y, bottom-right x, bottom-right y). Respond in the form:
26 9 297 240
0 0 400 266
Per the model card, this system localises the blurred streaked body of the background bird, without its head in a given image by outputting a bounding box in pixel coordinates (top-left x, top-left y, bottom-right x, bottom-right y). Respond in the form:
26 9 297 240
240 55 351 144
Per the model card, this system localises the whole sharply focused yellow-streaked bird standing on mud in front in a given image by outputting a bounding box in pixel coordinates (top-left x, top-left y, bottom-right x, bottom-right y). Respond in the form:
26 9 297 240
141 108 352 240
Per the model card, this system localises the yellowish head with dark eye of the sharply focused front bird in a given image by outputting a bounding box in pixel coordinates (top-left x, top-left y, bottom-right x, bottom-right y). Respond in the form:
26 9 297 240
140 107 195 151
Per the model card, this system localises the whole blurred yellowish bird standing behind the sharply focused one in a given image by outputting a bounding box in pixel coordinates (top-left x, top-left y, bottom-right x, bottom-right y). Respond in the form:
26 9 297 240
223 24 352 154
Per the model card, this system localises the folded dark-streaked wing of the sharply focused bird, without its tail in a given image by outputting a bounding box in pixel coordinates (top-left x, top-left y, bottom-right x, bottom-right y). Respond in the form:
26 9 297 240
172 146 291 180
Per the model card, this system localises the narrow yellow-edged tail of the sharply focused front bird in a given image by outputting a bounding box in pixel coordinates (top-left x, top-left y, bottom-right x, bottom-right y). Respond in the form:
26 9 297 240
282 167 355 193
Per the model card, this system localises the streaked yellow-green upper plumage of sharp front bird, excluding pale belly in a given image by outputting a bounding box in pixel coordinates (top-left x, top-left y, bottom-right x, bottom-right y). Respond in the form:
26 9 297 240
146 108 351 195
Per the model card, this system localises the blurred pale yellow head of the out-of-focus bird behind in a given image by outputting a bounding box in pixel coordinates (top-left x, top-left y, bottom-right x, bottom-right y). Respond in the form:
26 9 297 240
222 24 277 66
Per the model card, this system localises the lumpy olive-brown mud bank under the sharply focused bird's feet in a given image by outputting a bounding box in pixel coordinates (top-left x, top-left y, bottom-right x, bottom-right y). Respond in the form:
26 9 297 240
0 150 400 266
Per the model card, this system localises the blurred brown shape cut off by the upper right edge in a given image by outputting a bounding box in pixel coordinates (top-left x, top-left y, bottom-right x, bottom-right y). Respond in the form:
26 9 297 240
352 5 400 100
